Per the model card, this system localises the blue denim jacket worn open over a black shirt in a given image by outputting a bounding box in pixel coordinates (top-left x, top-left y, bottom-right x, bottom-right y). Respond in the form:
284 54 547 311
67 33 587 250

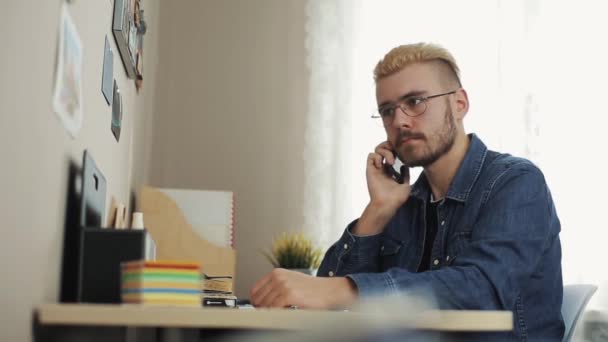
318 134 564 341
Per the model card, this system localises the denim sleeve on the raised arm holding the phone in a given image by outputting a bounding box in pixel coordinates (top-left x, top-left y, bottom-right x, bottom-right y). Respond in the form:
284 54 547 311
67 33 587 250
317 220 382 277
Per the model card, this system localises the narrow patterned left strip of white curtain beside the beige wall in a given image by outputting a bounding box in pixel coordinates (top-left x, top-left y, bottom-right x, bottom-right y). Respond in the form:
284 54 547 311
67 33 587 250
304 0 356 247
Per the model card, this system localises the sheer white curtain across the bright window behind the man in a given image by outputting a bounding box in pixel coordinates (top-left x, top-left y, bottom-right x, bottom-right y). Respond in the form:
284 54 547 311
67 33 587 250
304 0 608 307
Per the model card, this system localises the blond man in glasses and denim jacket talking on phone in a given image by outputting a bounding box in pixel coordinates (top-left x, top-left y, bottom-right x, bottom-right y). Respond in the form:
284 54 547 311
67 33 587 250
251 43 564 341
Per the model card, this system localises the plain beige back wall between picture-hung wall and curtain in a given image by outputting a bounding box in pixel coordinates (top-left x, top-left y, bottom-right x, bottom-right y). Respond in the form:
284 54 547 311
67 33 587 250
151 0 308 296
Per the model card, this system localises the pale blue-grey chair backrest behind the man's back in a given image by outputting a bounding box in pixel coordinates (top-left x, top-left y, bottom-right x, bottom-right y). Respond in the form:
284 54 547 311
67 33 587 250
562 284 597 342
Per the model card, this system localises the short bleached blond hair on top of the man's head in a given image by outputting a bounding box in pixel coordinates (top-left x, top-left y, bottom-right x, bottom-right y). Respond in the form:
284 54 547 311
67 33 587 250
374 43 461 86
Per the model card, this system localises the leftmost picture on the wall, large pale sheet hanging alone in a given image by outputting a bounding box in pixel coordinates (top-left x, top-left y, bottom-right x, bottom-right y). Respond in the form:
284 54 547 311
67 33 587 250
53 3 83 138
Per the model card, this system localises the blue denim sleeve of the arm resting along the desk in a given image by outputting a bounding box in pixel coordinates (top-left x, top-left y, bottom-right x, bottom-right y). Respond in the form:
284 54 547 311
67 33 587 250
348 163 561 309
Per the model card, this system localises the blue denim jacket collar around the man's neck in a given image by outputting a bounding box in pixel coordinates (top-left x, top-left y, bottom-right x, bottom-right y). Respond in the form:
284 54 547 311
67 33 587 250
411 133 488 202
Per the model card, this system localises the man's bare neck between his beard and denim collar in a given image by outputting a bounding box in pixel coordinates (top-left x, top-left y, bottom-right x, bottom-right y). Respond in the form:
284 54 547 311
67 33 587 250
424 132 469 200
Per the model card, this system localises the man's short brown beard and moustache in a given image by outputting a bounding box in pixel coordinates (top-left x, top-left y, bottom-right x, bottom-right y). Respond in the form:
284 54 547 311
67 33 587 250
397 108 456 167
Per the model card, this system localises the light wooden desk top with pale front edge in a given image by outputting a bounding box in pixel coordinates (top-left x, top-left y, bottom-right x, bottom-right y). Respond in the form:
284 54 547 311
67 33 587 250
36 304 513 341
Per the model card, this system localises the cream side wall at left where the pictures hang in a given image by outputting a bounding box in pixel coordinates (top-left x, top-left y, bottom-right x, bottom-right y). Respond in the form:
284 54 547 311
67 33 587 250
0 0 159 341
